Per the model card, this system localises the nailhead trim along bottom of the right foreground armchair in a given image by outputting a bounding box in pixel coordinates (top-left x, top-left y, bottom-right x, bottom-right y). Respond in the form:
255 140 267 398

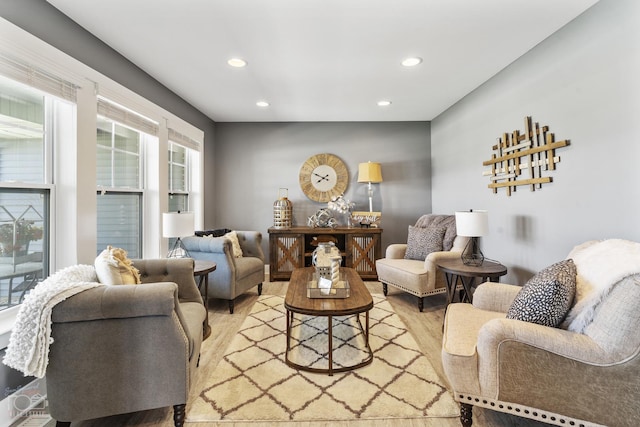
455 393 605 427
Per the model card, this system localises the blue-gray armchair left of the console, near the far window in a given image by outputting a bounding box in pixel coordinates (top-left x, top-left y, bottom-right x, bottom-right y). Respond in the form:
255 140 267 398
181 231 265 314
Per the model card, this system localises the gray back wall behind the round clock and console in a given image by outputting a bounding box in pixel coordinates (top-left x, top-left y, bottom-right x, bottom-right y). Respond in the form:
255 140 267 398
211 122 431 254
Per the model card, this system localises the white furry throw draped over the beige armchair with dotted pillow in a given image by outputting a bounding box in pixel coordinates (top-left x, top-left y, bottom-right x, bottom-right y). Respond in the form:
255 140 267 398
562 239 640 333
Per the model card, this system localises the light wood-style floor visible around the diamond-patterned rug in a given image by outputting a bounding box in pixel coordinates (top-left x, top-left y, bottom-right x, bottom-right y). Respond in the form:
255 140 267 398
47 282 547 427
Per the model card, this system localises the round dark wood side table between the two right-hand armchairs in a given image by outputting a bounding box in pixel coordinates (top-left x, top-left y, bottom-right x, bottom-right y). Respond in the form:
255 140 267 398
436 258 507 305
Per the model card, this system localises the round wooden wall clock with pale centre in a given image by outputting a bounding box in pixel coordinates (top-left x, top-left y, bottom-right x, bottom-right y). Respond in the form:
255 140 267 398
299 153 349 202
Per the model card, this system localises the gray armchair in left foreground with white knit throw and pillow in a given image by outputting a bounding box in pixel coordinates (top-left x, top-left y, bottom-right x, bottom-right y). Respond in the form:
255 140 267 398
3 258 205 427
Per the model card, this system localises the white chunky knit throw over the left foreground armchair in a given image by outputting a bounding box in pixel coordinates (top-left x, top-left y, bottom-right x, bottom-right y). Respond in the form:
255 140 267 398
2 265 103 378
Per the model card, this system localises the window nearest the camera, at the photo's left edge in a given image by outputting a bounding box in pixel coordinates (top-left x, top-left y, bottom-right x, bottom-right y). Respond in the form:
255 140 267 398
0 77 54 310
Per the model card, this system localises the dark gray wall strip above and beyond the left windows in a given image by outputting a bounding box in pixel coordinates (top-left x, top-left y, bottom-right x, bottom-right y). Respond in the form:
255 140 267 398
0 0 215 223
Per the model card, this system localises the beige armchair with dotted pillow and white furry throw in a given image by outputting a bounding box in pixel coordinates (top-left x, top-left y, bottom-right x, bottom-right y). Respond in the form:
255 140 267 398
442 239 640 427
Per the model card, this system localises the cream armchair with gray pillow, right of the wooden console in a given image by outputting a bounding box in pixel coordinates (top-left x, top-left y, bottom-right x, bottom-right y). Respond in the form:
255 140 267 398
376 214 469 311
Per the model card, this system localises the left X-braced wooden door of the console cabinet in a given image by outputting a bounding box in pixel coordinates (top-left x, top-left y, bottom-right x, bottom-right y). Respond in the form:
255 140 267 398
269 232 304 281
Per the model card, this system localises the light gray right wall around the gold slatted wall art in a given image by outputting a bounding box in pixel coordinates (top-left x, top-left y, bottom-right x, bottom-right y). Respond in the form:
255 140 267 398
431 0 640 284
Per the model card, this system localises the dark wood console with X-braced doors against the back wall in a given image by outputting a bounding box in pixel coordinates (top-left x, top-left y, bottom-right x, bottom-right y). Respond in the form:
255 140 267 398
268 227 382 281
